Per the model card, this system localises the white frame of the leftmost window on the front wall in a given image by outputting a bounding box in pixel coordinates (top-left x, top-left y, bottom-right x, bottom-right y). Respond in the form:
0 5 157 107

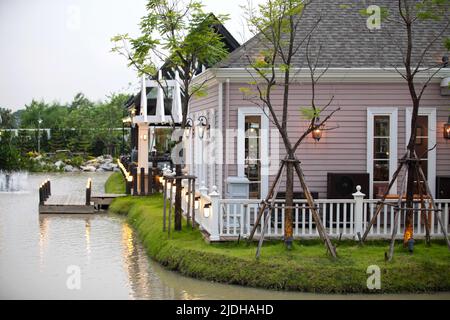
237 107 269 199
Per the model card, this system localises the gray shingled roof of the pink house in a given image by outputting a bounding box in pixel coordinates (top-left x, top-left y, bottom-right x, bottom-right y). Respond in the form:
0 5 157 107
217 0 450 68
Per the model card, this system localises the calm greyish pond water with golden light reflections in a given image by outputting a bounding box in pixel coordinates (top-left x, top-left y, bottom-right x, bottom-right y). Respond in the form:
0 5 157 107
0 174 450 299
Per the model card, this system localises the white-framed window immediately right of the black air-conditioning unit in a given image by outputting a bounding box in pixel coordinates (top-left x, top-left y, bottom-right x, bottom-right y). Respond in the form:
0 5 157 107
367 108 398 199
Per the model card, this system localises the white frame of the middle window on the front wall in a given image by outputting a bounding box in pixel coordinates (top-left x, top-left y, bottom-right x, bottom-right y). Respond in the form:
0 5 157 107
367 108 398 199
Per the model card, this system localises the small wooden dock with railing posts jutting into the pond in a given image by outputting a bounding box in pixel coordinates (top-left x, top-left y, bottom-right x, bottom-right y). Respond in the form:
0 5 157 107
39 179 125 214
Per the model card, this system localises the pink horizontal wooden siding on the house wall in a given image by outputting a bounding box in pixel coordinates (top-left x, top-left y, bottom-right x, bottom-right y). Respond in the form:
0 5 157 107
225 83 450 198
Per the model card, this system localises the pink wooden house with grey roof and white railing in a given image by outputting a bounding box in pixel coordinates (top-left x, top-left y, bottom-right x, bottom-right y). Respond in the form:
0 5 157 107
177 0 450 241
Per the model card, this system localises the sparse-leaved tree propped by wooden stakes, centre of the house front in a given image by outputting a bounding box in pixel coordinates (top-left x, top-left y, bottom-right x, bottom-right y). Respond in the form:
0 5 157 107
242 0 339 256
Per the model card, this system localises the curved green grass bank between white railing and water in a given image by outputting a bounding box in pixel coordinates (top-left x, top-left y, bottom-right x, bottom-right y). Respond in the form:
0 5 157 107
107 194 450 293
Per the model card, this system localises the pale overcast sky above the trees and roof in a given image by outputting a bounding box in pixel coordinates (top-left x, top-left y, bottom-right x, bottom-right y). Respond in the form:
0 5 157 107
0 0 263 110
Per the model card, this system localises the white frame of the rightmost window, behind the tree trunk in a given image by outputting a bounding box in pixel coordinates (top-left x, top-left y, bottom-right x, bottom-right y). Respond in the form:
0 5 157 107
405 108 437 197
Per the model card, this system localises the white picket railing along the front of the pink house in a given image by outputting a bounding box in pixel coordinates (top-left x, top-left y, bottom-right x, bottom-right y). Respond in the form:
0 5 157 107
176 181 450 241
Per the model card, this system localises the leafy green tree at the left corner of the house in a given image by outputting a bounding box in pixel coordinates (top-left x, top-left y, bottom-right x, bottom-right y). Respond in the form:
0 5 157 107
112 0 228 231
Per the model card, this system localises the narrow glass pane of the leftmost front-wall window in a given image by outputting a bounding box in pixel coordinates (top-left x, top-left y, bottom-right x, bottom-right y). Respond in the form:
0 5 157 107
244 116 261 199
